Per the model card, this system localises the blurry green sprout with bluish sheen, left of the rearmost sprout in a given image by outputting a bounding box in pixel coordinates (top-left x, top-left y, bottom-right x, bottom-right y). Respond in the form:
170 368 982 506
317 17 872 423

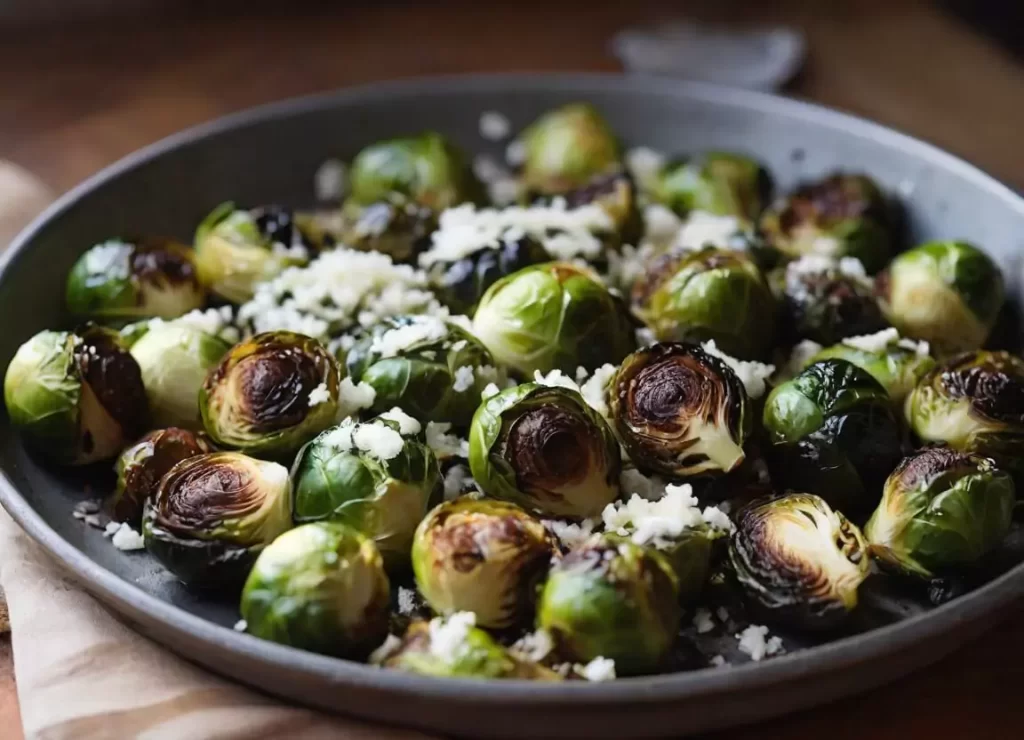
348 132 479 212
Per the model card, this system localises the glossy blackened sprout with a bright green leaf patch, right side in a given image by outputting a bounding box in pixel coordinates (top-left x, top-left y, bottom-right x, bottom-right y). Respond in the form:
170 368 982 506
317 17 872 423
764 359 902 516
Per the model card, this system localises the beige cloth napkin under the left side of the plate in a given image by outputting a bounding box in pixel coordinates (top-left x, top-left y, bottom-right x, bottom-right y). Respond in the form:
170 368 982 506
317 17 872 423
0 161 428 740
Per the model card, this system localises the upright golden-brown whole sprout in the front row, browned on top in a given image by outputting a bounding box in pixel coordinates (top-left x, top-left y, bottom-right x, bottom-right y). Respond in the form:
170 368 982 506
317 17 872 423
413 498 556 628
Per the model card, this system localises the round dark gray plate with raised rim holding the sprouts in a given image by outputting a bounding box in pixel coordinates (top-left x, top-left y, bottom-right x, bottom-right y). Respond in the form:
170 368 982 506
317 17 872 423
0 76 1024 738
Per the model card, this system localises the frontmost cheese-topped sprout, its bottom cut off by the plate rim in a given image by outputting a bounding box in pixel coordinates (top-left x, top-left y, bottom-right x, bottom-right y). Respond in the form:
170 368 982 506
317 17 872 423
382 612 561 681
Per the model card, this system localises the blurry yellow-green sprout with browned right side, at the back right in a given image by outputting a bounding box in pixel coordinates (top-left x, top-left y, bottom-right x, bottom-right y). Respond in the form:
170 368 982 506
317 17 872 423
651 151 771 223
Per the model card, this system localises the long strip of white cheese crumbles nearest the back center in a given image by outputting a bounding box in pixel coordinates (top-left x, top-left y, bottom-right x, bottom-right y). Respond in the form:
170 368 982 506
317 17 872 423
419 199 613 267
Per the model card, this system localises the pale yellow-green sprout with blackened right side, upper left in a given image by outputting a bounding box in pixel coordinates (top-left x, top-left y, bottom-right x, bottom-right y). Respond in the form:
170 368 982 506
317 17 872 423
195 203 321 303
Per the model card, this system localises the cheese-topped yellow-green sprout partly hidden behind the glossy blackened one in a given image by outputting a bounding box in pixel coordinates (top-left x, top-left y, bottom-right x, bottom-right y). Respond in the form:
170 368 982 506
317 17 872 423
808 329 935 407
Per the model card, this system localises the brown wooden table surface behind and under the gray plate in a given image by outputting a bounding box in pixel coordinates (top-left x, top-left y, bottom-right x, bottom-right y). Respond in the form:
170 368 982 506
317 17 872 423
0 0 1024 740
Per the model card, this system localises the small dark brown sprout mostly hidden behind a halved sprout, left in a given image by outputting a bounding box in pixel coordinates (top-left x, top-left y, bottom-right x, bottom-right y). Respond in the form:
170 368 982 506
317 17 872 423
111 427 213 525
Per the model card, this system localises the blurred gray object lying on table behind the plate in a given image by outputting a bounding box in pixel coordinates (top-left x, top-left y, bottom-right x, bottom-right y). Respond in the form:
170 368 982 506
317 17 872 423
612 21 807 90
